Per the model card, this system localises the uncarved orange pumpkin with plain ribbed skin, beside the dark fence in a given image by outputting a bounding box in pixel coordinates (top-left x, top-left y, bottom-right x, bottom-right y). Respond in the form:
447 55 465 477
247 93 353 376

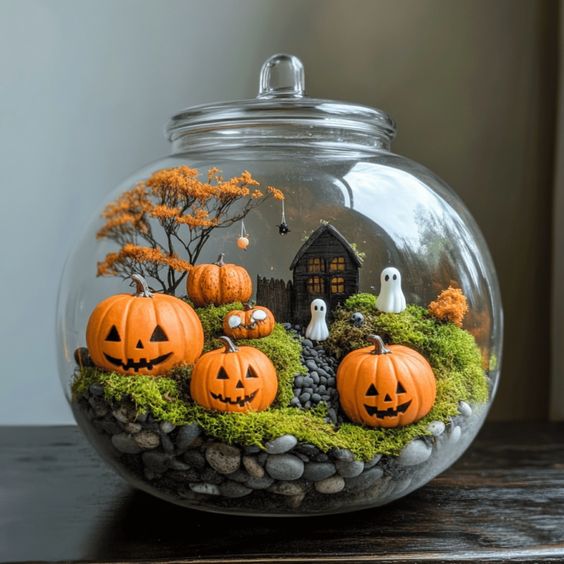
186 253 253 307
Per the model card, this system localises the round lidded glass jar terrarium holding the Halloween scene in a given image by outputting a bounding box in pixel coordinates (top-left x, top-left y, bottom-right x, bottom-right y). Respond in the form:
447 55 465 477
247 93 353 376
58 55 502 516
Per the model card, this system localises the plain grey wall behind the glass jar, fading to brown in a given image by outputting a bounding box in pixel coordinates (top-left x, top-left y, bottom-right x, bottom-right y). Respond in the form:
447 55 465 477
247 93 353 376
0 0 557 424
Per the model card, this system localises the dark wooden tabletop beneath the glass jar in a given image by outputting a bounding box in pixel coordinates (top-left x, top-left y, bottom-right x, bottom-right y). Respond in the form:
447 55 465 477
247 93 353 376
0 423 564 562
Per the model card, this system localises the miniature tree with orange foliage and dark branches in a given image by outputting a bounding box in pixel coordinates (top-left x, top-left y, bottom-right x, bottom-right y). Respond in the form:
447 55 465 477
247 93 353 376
97 166 284 294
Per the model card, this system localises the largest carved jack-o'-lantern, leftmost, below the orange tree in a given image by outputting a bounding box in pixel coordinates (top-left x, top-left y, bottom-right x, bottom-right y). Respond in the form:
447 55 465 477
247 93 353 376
86 274 204 376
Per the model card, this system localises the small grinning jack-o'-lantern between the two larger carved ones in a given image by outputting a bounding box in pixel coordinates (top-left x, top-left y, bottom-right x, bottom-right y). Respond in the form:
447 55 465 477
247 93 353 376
190 337 278 412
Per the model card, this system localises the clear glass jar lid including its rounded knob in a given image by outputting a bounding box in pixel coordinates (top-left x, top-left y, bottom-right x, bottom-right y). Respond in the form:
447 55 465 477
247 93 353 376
166 54 396 145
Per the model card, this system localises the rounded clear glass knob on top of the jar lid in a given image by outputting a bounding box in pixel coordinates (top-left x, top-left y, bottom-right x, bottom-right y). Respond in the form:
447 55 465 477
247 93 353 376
258 53 305 98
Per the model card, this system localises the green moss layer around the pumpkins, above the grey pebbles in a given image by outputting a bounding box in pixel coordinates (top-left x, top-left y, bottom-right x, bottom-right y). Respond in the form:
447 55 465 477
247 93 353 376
73 294 488 460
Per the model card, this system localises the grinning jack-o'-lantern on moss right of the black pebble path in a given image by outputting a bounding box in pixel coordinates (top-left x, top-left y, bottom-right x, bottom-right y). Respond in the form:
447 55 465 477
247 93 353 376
337 335 437 427
